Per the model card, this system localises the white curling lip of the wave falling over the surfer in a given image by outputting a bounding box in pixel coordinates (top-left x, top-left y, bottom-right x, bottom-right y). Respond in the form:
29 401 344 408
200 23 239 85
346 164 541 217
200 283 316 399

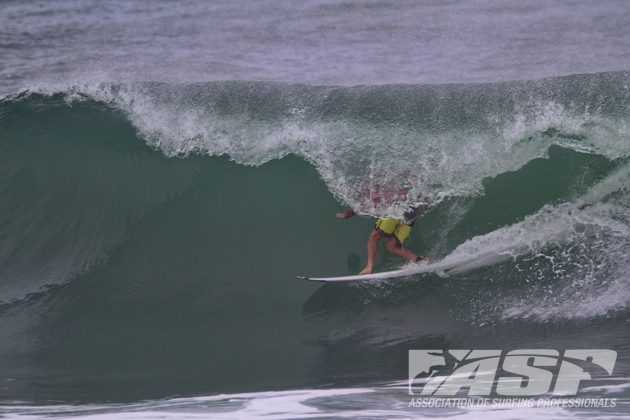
8 72 630 216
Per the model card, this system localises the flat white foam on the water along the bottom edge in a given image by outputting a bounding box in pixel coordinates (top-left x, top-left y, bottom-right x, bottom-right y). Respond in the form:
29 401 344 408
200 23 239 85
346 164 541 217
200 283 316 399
0 384 627 420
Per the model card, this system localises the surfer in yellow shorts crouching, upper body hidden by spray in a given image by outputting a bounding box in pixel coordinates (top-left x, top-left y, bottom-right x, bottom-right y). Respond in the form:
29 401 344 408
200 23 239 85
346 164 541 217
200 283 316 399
335 204 429 274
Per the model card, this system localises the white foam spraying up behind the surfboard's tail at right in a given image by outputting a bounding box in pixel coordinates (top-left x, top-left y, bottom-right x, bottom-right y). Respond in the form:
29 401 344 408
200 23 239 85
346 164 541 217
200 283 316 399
436 166 630 320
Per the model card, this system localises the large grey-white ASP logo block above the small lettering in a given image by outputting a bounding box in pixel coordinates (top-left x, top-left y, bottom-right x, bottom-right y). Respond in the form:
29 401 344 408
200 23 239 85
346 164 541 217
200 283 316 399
409 349 617 397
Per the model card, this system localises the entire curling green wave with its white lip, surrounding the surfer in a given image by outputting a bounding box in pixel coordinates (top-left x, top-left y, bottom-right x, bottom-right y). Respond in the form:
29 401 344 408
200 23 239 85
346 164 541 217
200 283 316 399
0 73 630 400
